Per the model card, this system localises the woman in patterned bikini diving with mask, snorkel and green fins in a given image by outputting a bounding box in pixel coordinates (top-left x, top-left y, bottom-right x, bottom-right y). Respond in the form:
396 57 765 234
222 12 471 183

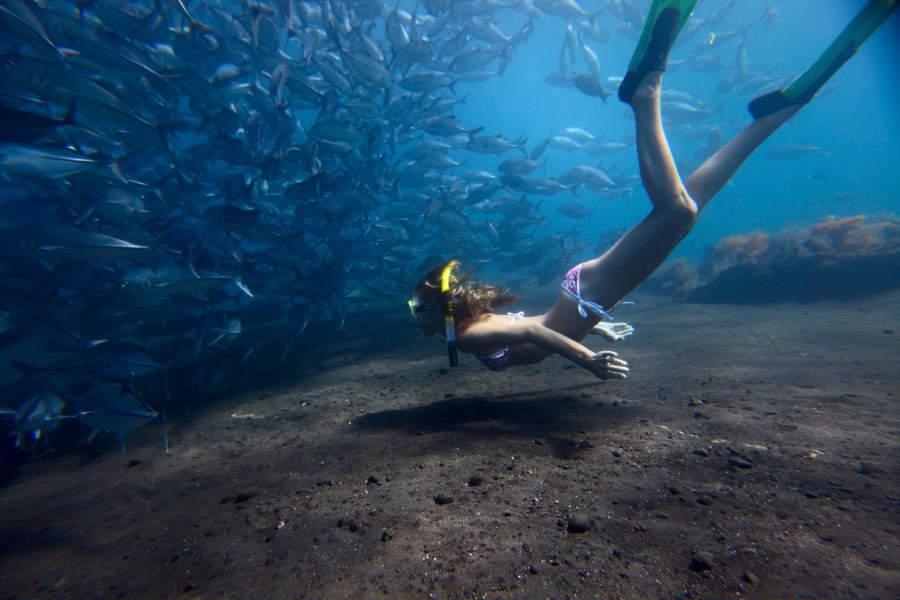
409 0 897 380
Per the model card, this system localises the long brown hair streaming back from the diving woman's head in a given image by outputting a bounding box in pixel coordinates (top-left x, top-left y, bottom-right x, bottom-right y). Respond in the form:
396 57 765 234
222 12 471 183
415 260 519 319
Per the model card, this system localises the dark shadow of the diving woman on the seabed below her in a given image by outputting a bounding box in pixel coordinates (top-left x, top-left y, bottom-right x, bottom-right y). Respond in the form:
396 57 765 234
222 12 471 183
354 384 631 457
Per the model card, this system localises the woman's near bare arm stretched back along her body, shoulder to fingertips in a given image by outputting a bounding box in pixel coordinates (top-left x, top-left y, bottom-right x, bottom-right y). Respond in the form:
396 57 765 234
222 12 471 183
457 316 628 380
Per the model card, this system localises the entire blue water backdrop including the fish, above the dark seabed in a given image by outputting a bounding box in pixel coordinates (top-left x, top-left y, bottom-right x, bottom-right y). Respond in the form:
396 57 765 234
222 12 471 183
0 0 900 454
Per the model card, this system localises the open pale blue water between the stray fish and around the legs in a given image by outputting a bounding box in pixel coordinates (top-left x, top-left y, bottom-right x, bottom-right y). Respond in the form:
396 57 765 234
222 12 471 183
458 0 900 259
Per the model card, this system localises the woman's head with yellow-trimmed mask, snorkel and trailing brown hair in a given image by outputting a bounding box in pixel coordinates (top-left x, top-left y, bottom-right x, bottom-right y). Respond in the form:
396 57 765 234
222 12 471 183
409 260 518 337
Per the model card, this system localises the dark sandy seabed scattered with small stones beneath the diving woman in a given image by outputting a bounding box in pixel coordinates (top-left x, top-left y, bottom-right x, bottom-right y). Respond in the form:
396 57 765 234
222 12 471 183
0 294 900 599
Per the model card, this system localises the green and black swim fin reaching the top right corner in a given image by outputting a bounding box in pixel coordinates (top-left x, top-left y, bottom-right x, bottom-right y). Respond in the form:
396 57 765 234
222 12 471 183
747 0 898 119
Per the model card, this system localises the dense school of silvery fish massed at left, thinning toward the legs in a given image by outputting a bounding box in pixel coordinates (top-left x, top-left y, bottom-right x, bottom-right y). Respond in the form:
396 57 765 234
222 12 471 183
0 0 808 452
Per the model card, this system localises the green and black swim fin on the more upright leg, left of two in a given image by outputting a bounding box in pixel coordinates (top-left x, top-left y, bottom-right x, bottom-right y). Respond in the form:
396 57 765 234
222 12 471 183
619 0 697 104
